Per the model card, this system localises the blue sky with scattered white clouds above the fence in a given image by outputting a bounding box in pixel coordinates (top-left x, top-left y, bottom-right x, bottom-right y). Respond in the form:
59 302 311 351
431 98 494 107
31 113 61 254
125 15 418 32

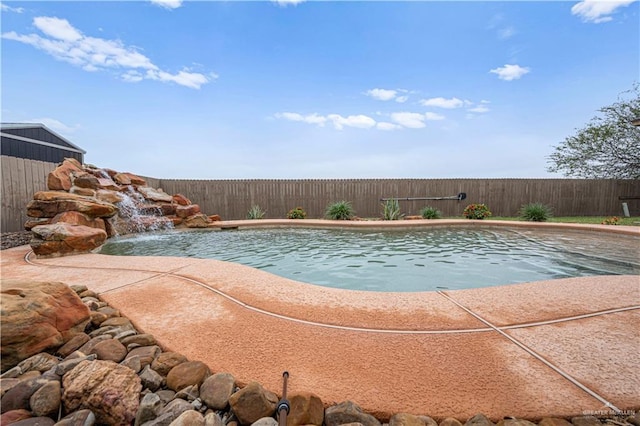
0 0 640 179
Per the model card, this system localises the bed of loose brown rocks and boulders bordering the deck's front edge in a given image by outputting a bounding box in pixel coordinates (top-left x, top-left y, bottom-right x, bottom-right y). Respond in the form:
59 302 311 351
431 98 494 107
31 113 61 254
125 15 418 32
0 280 640 426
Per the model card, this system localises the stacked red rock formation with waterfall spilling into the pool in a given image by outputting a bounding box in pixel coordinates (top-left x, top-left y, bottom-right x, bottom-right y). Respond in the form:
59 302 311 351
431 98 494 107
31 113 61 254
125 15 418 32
25 158 219 256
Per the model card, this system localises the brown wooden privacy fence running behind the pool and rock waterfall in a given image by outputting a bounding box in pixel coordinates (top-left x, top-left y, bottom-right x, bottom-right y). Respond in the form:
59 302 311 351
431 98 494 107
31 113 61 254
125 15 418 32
1 156 640 232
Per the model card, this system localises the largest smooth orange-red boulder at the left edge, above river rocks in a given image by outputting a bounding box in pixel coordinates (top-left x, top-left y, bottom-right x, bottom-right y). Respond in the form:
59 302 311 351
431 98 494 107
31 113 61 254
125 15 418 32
0 280 89 371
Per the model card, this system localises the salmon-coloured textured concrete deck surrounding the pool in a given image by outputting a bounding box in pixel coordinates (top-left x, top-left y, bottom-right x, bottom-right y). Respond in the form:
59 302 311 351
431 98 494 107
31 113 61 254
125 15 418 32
0 220 640 422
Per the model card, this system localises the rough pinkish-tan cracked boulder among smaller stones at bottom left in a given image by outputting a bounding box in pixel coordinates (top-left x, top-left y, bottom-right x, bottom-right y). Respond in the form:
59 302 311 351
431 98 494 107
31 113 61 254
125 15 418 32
62 361 142 425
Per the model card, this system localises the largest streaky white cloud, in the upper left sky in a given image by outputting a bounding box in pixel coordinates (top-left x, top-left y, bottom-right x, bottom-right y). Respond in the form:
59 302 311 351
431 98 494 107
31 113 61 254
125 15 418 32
2 17 218 89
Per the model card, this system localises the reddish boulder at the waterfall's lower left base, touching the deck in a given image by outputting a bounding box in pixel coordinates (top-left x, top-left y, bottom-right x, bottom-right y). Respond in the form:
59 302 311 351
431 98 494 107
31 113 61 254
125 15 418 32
31 222 107 256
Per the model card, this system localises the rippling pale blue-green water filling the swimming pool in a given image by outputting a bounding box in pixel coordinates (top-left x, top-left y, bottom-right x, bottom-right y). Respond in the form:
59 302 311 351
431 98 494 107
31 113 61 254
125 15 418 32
100 227 640 292
